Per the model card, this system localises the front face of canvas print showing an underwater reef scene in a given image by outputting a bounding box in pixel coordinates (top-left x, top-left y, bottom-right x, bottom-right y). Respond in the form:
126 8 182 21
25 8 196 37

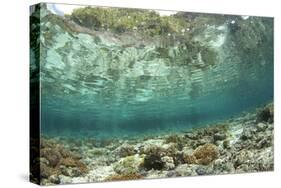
30 4 274 185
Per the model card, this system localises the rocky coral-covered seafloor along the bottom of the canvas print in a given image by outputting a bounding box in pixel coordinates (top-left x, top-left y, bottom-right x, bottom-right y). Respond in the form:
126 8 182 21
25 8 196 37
32 103 274 185
